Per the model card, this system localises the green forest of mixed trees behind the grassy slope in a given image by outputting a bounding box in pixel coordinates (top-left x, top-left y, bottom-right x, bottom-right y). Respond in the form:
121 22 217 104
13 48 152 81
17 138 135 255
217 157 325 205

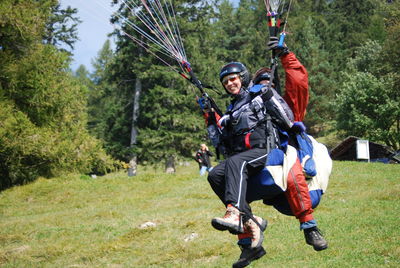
0 0 400 189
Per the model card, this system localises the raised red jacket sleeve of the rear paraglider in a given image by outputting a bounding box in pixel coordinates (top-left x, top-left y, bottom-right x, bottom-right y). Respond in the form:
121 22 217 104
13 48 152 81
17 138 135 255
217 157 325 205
281 52 308 121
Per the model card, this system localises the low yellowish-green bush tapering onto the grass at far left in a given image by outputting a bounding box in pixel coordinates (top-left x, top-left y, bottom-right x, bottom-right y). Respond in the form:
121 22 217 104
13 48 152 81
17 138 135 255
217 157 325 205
0 99 119 189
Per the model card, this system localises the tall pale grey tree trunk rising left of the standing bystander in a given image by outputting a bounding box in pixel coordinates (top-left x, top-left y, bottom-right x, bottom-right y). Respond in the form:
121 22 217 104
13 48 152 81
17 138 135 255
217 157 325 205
128 78 142 177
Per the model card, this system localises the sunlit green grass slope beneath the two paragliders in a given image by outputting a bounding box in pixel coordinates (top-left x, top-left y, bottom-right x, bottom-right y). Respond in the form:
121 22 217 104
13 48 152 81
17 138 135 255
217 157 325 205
0 162 400 268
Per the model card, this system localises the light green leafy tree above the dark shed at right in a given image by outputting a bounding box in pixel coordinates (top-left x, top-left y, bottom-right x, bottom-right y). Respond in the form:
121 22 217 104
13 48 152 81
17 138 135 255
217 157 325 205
337 41 400 150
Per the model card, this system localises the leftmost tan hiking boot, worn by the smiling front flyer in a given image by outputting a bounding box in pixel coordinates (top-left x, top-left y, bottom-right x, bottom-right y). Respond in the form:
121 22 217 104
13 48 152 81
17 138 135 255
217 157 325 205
211 205 243 234
